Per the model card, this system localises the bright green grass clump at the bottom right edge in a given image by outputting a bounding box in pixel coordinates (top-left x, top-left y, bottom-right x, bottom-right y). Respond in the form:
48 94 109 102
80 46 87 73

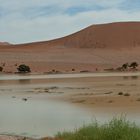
56 118 140 140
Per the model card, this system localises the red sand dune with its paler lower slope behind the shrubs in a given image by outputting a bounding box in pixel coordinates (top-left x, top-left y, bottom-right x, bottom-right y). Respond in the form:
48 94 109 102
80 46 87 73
0 22 140 72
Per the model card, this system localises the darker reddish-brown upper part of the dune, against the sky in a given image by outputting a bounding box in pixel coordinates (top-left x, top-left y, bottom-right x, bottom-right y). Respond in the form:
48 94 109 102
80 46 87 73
7 22 140 49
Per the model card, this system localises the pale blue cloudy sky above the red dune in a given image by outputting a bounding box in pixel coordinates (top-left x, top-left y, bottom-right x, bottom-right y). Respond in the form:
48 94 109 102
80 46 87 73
0 0 140 43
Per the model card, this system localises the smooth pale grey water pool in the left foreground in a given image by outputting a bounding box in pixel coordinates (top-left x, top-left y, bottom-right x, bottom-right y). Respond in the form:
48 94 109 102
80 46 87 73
0 95 95 137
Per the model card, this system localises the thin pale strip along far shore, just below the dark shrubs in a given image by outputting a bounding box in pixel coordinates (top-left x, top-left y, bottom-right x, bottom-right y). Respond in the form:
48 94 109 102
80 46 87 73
0 71 140 80
